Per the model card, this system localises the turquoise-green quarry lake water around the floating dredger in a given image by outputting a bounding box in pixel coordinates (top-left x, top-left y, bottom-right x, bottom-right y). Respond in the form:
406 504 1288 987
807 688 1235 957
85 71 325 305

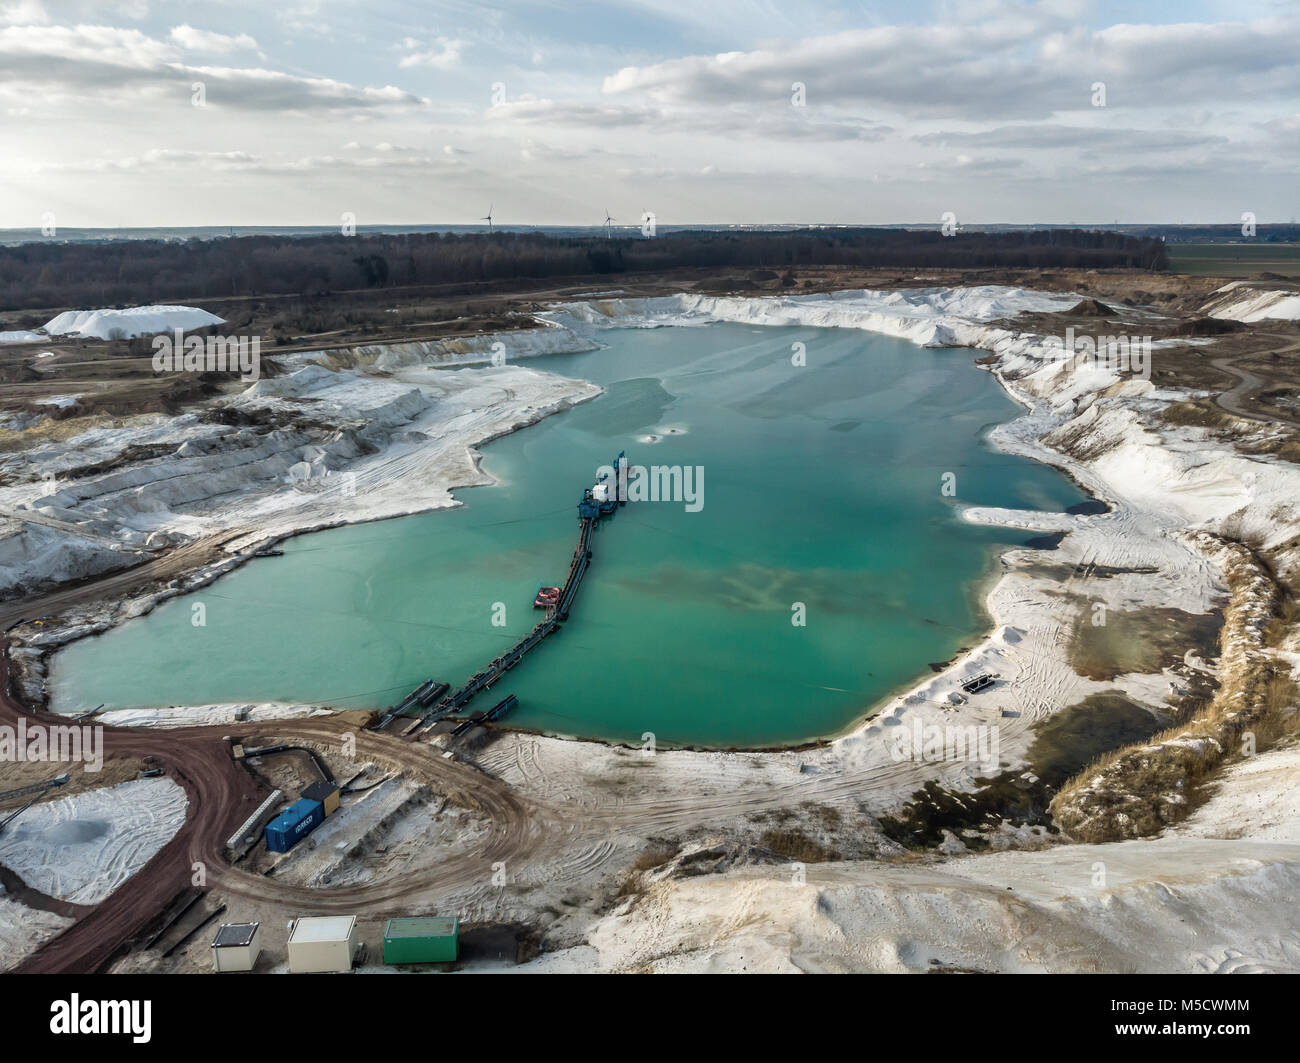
52 325 1084 749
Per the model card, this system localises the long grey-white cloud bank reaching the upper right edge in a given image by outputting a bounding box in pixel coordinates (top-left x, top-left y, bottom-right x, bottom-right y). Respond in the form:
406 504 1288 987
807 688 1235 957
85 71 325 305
603 16 1300 121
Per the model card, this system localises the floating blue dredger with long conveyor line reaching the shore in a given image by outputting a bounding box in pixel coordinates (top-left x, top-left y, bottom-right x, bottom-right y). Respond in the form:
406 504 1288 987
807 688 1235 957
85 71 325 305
373 451 627 734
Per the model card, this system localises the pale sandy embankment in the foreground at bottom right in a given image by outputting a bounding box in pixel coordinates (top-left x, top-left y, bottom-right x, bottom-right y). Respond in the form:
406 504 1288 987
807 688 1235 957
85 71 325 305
529 745 1300 973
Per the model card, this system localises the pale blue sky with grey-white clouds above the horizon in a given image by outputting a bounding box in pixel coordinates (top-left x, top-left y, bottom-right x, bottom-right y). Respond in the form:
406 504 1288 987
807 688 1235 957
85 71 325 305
0 0 1300 227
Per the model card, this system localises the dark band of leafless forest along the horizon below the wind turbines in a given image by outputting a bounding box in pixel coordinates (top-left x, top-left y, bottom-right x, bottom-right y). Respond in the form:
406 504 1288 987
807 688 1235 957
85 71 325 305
0 229 1166 311
